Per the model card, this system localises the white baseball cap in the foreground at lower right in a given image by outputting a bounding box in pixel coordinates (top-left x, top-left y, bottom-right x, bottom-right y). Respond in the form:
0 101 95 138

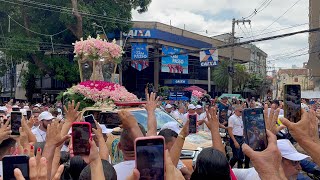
277 139 309 161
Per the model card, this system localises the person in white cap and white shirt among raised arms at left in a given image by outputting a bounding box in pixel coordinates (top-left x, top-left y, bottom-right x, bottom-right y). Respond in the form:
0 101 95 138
32 111 55 142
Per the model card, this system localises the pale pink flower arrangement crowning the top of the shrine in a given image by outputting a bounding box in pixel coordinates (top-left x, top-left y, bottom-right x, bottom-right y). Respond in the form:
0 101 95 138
73 36 123 63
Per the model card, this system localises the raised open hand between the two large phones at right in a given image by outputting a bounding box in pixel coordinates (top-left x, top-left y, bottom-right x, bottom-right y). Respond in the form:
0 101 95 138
263 104 285 135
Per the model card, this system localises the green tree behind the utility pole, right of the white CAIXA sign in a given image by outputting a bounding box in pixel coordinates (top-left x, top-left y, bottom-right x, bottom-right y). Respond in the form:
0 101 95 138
212 59 249 92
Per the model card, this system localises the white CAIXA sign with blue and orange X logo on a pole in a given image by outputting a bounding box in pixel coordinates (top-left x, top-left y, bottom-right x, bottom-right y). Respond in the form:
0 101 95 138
200 49 219 66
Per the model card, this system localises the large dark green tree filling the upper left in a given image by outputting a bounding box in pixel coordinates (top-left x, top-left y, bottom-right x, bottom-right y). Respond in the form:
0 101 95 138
0 0 151 101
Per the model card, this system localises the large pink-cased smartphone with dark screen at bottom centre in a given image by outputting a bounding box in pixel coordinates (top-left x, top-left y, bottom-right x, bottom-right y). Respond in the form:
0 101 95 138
135 136 165 180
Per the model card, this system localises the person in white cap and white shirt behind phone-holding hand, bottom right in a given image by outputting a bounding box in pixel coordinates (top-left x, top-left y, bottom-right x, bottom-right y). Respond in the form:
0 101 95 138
232 139 309 180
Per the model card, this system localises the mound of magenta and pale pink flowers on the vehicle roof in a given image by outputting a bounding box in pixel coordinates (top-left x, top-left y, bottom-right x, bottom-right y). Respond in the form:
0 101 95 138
60 81 138 109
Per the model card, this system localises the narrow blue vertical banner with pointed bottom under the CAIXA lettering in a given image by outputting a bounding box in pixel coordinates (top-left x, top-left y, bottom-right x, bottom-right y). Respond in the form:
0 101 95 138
131 43 149 71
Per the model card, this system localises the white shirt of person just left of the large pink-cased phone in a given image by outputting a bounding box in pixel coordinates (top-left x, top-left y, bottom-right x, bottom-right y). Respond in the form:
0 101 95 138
113 160 136 180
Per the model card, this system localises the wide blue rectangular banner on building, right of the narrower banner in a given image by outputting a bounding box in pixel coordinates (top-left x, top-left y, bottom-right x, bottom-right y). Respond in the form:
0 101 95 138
161 46 188 74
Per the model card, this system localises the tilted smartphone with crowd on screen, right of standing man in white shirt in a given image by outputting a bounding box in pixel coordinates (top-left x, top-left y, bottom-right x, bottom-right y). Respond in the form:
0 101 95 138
242 108 268 151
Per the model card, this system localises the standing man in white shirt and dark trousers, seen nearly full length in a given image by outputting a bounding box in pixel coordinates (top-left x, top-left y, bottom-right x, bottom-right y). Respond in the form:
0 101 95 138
228 106 249 168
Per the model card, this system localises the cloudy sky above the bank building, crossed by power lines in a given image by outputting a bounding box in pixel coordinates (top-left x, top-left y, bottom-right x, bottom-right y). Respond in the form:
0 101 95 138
133 0 309 70
